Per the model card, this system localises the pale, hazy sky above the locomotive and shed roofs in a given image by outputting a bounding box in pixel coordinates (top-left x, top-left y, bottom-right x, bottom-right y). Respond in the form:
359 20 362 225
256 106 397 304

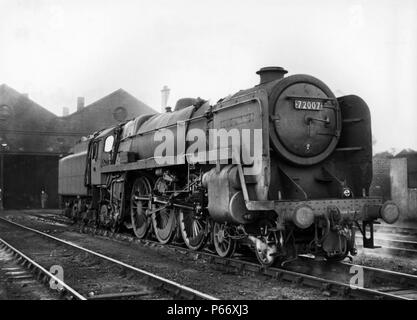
0 0 417 152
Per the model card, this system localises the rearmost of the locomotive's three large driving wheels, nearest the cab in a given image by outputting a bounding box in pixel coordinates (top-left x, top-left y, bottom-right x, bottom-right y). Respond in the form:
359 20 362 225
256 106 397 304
130 177 152 239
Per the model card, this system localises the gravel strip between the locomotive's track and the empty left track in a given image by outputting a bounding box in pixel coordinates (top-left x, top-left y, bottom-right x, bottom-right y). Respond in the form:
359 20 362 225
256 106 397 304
0 212 334 299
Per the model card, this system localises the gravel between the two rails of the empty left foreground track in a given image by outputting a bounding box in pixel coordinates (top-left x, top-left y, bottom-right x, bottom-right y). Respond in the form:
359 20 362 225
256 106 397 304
0 222 179 299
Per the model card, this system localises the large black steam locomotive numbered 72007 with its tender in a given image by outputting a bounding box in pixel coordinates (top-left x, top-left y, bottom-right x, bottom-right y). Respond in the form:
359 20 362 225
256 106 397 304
59 67 400 266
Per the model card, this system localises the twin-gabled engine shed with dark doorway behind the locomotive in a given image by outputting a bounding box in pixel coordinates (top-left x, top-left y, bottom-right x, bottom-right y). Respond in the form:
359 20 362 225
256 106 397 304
0 84 155 209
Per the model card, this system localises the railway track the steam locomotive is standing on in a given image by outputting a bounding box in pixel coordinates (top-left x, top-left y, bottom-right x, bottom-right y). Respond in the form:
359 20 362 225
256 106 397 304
3 212 417 300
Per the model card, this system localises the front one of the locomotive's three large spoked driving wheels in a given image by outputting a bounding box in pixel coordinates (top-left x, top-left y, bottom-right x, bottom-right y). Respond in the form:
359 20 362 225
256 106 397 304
179 209 208 250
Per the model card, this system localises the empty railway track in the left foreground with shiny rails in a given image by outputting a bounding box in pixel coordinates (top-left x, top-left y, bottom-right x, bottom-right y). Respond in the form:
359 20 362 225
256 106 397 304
0 218 216 300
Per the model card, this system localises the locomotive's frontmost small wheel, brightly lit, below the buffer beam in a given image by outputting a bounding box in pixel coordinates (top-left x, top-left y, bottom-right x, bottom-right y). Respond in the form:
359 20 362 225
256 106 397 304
255 222 278 267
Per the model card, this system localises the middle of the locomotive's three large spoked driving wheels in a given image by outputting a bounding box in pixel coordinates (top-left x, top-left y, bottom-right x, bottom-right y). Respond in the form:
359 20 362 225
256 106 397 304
152 208 177 244
